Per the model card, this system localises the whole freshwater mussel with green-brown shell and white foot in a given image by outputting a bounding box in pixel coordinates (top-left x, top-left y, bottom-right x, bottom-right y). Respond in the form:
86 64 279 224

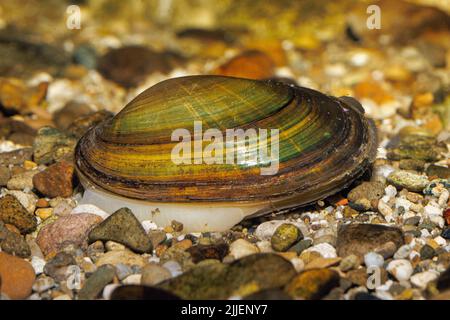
76 76 377 231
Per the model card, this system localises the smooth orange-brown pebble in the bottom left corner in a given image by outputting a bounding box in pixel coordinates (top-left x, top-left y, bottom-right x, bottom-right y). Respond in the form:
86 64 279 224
0 252 35 299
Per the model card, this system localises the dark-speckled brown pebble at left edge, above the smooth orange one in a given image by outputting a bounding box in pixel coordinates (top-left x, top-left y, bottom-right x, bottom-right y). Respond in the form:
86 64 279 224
0 195 37 233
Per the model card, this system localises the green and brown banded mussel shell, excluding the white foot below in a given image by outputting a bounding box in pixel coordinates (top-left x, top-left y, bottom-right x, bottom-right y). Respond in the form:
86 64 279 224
76 76 377 214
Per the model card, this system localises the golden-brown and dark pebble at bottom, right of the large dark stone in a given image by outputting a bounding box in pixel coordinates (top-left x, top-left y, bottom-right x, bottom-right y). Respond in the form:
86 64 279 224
286 269 339 300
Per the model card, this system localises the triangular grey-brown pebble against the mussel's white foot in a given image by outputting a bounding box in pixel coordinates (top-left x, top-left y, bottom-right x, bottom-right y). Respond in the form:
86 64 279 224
89 208 152 253
